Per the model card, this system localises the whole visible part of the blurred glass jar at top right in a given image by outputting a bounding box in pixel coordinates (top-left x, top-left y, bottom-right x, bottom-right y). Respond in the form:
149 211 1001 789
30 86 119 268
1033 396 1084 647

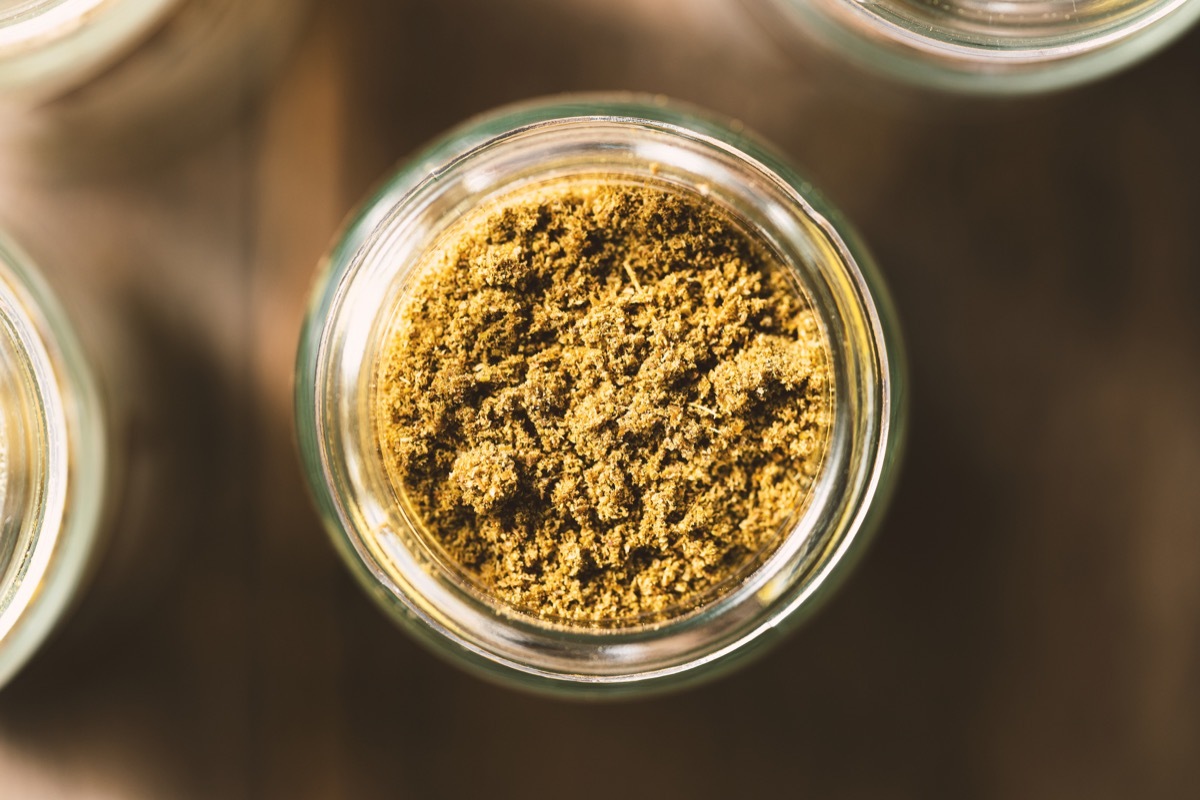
752 0 1200 94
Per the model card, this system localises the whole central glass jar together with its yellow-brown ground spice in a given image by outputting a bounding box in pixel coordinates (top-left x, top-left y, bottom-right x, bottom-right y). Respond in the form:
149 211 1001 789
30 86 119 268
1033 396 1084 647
295 95 905 697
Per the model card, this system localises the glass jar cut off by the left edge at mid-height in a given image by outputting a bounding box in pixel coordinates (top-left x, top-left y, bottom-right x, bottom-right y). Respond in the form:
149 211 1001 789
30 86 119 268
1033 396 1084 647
0 239 108 686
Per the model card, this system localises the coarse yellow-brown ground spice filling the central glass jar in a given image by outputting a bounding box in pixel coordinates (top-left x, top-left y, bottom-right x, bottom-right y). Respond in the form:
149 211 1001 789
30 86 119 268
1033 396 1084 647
373 176 834 625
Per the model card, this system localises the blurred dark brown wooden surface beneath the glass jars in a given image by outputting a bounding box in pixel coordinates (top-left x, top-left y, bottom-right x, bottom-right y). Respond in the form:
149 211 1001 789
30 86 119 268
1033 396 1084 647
0 0 1200 800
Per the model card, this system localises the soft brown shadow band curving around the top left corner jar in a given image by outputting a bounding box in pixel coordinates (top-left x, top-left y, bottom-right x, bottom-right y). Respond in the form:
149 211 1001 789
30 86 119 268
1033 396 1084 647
0 0 311 178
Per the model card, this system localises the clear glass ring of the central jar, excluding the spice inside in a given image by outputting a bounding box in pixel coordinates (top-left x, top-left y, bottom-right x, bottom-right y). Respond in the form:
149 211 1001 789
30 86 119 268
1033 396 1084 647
295 95 905 694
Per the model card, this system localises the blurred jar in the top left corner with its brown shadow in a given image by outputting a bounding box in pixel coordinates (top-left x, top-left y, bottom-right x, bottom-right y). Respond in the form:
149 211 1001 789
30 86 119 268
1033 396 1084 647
0 0 310 170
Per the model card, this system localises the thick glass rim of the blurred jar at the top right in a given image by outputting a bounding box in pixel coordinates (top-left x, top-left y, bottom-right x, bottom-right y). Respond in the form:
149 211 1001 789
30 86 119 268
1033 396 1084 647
761 0 1200 94
